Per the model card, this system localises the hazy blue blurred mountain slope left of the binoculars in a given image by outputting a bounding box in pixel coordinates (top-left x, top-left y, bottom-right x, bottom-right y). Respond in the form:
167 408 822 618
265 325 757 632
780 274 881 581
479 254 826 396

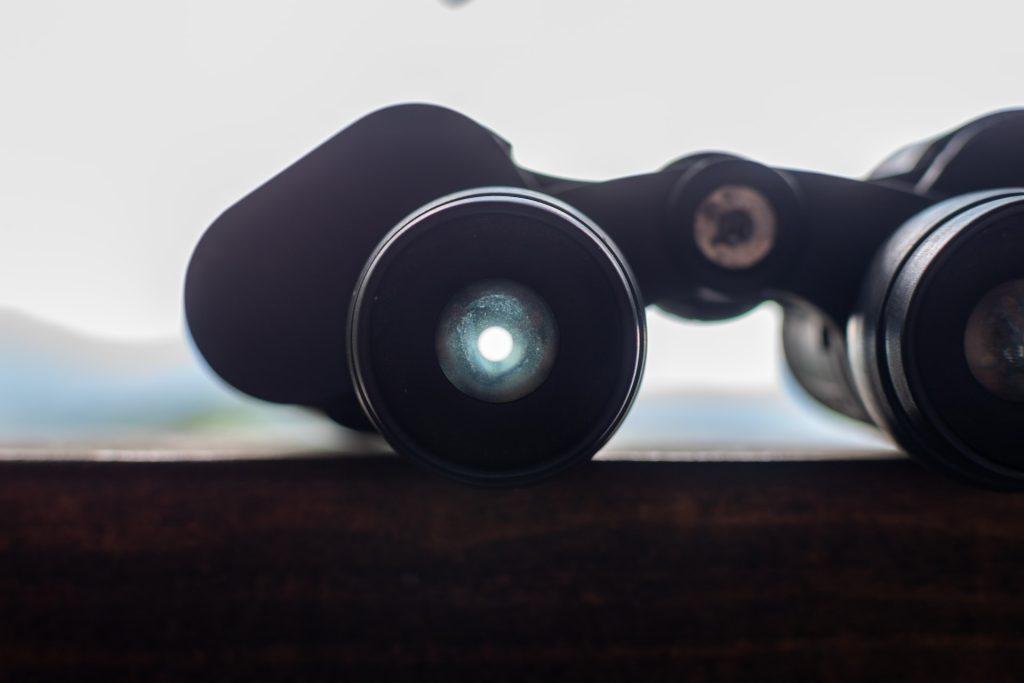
0 310 260 440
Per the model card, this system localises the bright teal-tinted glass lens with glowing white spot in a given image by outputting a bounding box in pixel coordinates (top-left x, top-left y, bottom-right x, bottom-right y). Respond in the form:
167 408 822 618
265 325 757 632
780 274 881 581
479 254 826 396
435 280 558 403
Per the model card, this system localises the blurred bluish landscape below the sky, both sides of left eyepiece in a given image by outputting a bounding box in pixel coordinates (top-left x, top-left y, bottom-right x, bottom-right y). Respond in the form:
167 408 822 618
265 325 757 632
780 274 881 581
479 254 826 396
0 310 886 458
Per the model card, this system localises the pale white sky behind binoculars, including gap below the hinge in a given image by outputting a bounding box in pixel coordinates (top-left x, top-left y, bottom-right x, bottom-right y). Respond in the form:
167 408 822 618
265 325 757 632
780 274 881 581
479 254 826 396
0 0 1024 393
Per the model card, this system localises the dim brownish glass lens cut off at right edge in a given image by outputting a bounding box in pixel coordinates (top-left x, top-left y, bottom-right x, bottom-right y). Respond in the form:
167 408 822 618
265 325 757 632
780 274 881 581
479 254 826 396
964 280 1024 401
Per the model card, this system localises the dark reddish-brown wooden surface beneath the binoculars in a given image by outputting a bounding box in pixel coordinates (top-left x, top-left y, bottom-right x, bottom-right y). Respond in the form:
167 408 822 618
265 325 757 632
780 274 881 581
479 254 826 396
0 458 1024 681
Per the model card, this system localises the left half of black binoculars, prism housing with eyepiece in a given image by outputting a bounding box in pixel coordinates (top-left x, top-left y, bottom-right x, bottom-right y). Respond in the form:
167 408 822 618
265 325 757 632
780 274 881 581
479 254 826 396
185 105 646 485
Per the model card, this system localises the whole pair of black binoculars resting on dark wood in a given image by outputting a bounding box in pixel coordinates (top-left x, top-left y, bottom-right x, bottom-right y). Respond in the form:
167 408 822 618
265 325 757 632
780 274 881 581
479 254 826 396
184 104 1024 489
